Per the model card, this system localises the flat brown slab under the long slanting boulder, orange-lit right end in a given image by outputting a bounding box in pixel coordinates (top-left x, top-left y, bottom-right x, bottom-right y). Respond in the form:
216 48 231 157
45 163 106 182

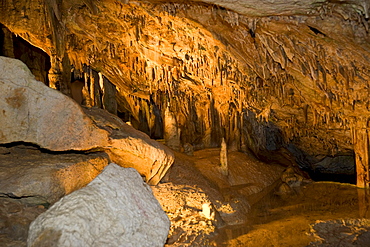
0 145 109 204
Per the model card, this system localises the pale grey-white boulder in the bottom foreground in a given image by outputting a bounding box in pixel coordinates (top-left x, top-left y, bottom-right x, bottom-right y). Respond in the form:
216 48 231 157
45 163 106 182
28 164 170 247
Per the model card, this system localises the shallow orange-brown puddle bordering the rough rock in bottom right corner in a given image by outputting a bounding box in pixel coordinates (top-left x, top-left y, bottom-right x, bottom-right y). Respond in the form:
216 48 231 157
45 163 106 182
213 182 370 247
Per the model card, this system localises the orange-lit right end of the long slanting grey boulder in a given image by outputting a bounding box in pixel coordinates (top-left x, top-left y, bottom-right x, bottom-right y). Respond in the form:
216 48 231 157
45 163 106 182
85 108 174 184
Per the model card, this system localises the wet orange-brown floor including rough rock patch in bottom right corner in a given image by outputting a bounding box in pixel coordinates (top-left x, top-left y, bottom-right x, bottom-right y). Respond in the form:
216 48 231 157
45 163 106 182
213 182 370 247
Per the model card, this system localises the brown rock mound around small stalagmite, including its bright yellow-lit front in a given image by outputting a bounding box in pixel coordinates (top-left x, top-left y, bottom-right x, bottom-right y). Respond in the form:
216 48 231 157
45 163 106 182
152 149 284 246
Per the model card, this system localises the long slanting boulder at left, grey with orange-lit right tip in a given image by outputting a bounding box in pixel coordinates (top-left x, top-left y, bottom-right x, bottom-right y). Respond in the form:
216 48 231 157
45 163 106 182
0 57 174 184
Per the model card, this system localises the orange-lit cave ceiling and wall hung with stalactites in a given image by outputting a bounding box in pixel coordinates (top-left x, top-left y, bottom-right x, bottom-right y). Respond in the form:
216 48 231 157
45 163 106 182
0 0 370 187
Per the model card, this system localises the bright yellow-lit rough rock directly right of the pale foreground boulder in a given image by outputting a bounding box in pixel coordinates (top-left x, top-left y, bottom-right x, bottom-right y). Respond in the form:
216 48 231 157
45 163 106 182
152 183 218 246
